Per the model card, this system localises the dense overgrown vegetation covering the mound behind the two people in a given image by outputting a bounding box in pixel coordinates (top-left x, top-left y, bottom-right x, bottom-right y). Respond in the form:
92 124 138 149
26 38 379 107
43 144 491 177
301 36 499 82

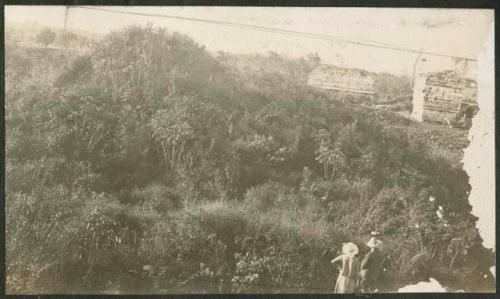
6 27 494 293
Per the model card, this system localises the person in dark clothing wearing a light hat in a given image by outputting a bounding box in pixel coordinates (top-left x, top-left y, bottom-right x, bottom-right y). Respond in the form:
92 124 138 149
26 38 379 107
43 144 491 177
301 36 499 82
360 237 387 293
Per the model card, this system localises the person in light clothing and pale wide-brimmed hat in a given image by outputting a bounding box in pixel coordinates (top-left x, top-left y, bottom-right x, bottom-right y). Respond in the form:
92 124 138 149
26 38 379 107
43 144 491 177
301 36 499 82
332 242 360 293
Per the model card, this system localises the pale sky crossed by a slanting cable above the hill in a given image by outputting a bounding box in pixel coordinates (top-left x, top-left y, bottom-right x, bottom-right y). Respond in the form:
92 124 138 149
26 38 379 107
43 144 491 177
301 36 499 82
5 6 494 75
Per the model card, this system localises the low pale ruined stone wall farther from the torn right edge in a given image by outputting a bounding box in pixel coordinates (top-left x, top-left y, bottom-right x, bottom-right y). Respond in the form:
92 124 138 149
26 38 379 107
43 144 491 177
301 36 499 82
307 64 375 95
